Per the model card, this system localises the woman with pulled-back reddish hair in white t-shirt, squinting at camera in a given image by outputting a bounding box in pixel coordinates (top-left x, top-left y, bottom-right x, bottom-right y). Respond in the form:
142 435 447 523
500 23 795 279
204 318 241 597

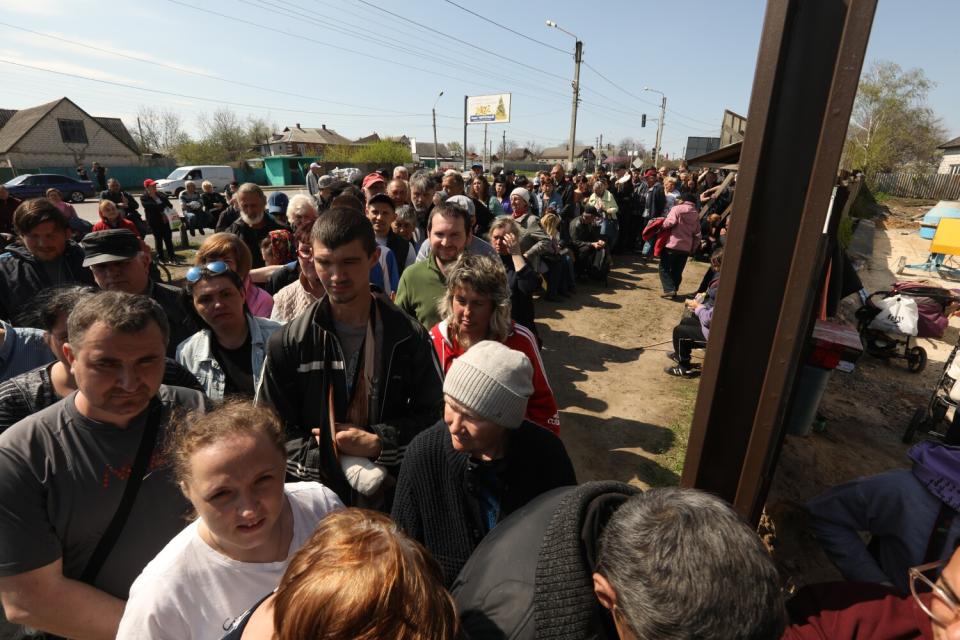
117 401 343 640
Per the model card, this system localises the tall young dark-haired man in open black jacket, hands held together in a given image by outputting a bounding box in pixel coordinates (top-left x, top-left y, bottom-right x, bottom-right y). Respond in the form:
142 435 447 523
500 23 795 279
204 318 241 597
256 207 443 508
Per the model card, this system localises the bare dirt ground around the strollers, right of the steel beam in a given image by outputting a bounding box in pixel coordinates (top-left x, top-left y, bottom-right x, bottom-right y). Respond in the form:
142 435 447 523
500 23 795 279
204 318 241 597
767 200 960 586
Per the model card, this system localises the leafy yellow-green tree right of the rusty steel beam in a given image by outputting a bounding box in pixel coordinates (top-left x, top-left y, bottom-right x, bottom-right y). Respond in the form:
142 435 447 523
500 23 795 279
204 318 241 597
842 60 946 173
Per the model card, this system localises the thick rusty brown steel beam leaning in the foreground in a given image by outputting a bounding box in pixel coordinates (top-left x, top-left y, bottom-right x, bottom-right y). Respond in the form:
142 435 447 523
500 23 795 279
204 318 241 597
681 0 877 521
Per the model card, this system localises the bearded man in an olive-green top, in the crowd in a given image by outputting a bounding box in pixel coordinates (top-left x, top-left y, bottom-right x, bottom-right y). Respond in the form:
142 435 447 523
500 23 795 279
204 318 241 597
396 203 473 328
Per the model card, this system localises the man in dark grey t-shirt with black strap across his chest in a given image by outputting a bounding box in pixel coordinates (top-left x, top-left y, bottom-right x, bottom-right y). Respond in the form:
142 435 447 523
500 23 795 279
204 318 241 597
0 292 205 638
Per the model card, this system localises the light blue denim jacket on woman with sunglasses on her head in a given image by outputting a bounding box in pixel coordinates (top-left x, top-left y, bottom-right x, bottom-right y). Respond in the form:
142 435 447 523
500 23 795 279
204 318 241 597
177 313 282 401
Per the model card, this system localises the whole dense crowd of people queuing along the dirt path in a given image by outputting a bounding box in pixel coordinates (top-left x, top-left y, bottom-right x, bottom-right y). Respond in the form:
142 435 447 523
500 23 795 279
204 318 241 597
0 165 948 640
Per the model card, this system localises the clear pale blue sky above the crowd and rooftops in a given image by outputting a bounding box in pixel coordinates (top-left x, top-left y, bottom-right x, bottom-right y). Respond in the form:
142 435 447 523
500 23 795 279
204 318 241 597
0 0 960 156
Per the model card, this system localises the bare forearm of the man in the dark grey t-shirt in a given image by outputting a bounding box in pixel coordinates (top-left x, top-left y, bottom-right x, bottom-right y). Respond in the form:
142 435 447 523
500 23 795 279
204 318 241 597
0 560 124 640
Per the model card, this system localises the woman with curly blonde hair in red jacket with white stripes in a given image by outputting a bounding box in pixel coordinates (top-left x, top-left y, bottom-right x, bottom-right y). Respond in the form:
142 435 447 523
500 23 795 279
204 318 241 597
430 253 560 433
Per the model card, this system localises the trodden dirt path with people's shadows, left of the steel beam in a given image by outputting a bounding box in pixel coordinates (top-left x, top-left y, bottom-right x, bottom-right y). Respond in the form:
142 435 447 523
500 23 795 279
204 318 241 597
537 256 706 487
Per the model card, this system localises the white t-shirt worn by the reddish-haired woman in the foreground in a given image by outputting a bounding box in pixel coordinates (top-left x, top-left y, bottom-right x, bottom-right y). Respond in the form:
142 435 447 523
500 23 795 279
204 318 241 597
117 482 343 640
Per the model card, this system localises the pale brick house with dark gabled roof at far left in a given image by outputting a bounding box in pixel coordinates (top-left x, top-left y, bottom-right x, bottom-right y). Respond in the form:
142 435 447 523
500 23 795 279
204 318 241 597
0 98 140 169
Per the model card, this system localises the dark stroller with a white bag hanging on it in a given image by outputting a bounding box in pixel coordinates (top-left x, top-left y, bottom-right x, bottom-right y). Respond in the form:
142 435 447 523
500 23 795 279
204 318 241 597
856 282 960 373
